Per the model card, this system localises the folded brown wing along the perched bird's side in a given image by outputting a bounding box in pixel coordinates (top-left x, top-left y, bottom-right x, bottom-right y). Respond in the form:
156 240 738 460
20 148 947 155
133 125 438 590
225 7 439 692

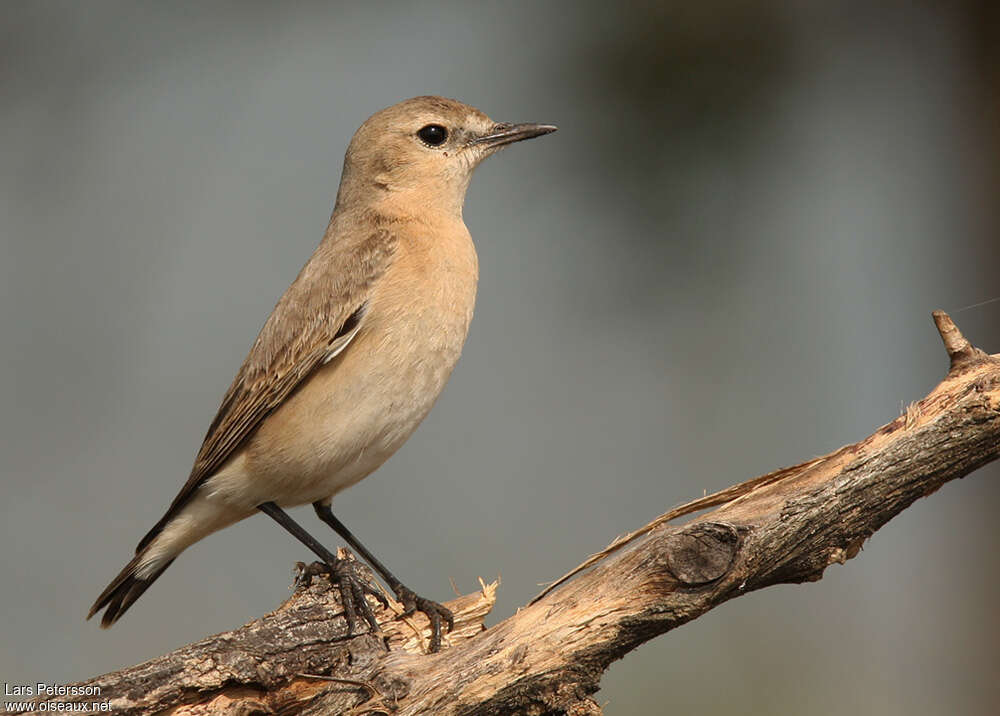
136 230 395 553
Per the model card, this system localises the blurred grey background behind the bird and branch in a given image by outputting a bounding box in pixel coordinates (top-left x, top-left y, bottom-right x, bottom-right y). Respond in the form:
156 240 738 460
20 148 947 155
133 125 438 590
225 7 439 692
0 0 1000 716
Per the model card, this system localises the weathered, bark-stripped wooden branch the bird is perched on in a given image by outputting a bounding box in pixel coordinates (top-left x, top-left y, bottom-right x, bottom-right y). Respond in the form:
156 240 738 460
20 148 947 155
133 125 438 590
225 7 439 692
41 312 1000 716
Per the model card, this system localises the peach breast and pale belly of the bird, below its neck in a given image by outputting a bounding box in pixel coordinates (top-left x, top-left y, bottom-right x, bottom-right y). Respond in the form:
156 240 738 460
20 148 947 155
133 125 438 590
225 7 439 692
206 225 478 509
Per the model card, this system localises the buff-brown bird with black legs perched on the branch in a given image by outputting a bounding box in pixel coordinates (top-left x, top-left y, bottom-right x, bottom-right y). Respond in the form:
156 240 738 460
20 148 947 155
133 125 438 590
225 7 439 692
87 96 557 651
